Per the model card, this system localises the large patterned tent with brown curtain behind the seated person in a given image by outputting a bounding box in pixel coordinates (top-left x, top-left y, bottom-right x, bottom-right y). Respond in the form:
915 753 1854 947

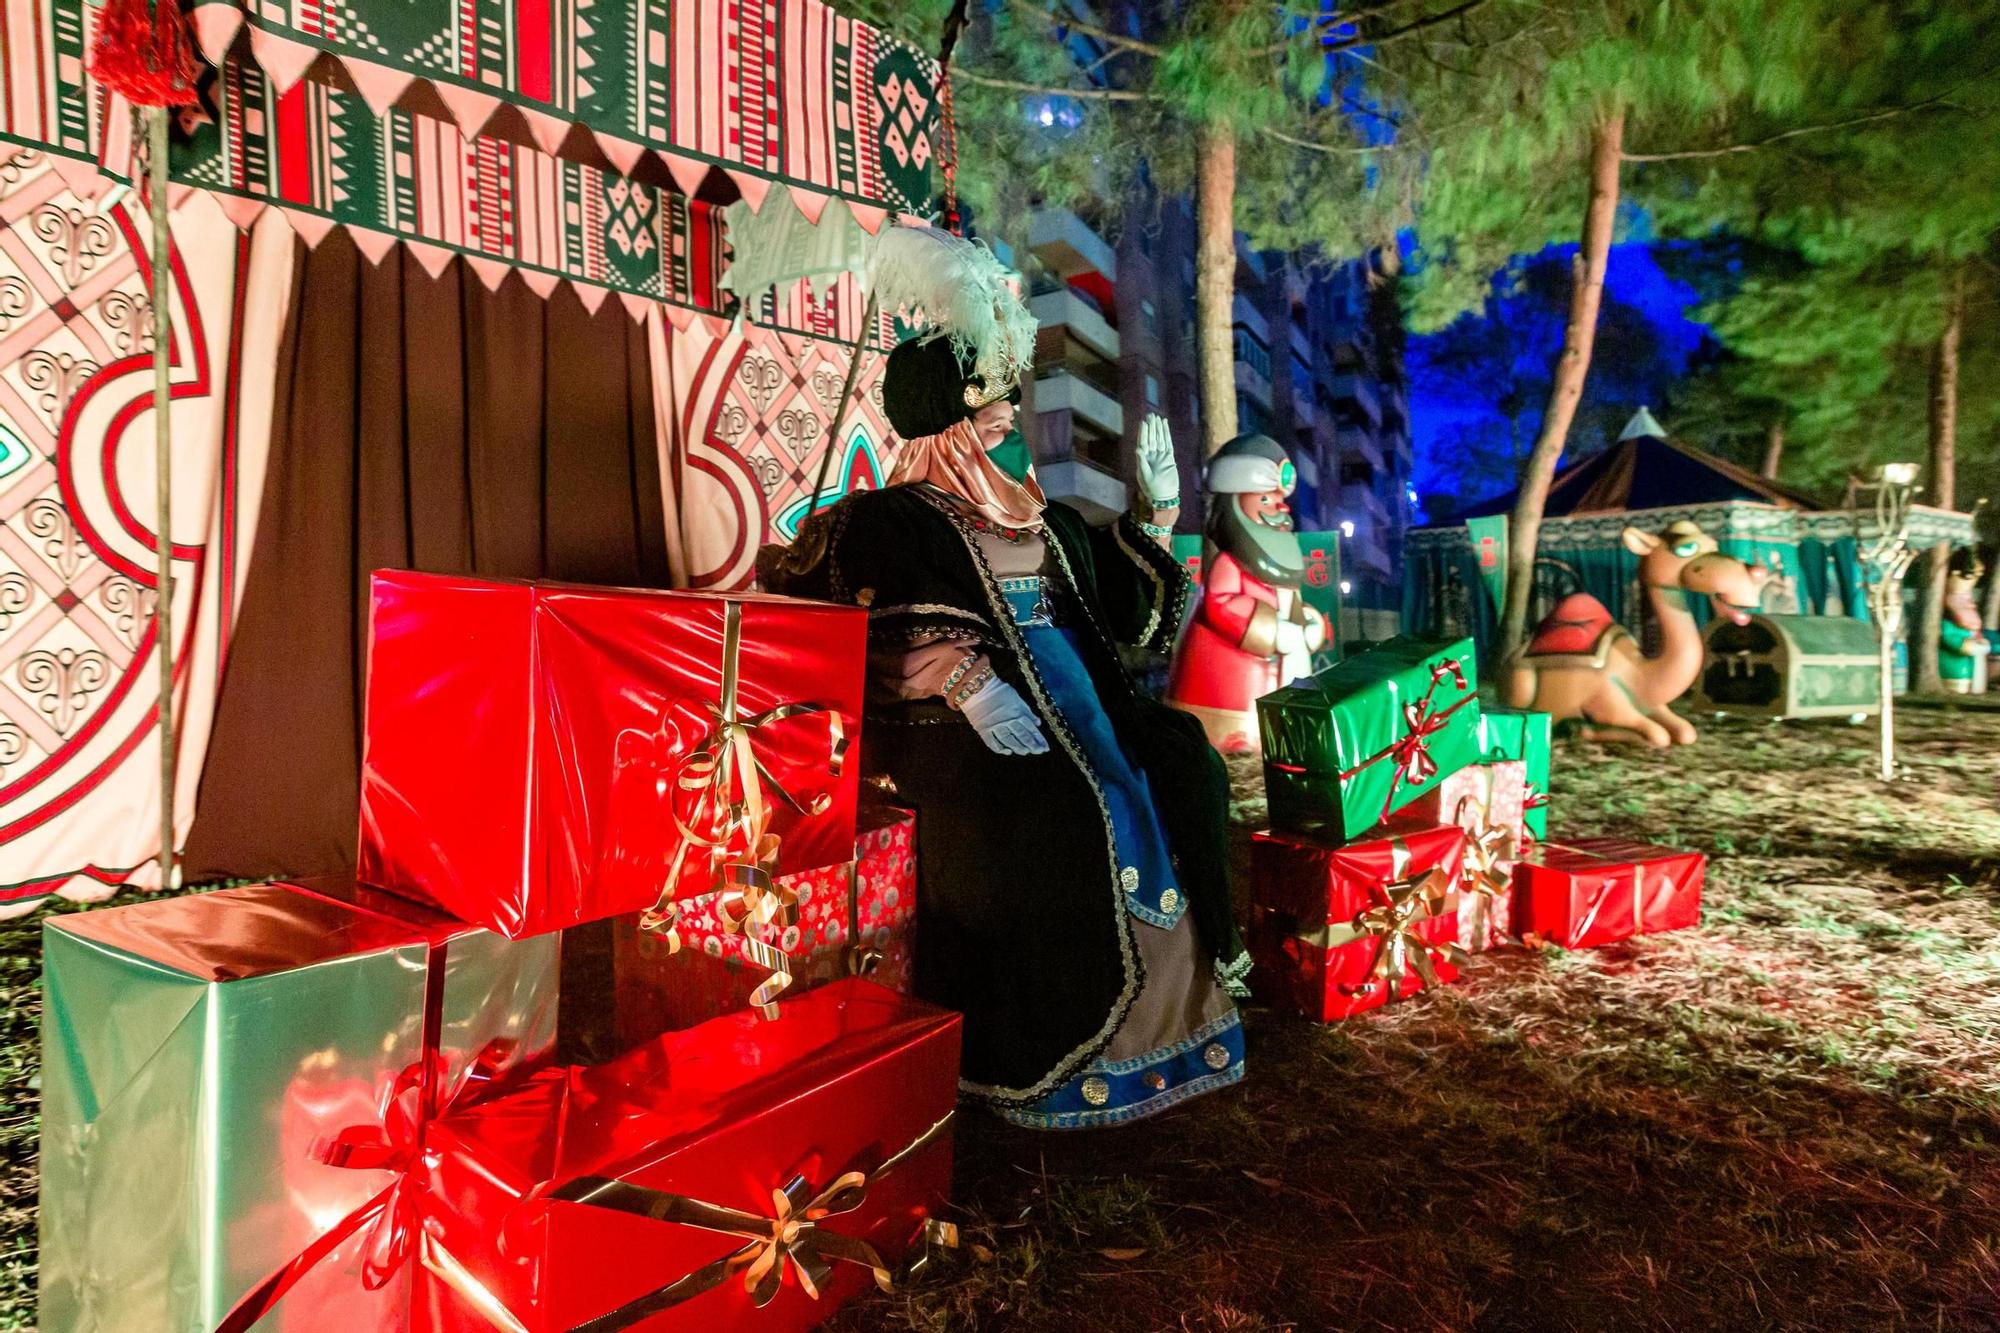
0 0 938 911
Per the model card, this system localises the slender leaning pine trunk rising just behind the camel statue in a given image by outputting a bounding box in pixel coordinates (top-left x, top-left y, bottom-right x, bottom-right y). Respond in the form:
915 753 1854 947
1500 110 1624 658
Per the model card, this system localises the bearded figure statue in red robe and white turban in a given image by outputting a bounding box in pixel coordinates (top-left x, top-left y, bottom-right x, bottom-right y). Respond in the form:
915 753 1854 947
1166 434 1330 755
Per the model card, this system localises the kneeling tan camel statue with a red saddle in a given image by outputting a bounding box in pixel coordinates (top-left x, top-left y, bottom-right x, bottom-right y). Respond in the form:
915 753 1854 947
1500 522 1770 747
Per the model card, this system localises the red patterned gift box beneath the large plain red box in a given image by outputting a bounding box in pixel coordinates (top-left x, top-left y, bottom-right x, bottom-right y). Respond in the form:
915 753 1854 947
612 805 916 1047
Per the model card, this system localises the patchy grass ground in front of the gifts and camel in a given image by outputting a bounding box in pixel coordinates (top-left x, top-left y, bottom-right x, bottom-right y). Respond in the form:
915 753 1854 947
0 709 2000 1333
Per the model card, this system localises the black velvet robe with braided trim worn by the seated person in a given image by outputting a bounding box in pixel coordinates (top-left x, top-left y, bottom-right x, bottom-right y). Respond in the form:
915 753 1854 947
766 486 1248 1103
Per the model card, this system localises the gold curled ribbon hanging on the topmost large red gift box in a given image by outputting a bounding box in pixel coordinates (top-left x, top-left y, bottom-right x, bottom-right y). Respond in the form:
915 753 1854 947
638 602 848 1019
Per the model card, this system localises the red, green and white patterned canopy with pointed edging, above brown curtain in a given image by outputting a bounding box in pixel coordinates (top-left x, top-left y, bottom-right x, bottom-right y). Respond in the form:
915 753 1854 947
0 0 938 342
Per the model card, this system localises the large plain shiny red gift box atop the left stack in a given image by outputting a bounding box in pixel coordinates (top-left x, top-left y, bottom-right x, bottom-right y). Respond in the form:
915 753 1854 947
360 572 866 939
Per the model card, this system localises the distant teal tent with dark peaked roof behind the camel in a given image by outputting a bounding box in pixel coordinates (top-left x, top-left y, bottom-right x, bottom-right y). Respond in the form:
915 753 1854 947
1402 408 1972 650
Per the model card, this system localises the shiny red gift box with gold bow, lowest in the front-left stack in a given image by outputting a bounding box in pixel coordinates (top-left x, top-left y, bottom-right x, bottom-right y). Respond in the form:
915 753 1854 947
426 981 960 1333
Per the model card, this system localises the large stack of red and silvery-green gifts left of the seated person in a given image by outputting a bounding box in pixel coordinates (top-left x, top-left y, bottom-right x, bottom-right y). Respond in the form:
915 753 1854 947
40 574 958 1333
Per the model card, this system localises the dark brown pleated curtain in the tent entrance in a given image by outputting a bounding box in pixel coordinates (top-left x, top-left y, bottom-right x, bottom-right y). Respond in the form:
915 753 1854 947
184 234 668 881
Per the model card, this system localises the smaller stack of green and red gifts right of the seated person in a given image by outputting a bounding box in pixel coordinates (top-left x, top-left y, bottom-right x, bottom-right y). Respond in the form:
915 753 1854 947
1250 638 1706 1023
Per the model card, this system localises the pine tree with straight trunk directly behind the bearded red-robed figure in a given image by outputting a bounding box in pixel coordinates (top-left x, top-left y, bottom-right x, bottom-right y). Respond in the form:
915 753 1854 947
886 0 1456 452
